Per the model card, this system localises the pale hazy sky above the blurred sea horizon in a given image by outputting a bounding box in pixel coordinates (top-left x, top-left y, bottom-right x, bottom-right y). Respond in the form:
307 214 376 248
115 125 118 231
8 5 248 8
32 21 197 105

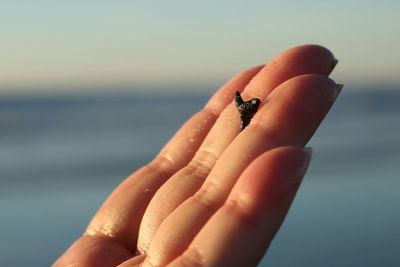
0 0 400 94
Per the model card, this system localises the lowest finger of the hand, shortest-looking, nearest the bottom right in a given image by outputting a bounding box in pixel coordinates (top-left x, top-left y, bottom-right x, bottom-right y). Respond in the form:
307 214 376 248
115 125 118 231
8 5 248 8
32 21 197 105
169 147 310 267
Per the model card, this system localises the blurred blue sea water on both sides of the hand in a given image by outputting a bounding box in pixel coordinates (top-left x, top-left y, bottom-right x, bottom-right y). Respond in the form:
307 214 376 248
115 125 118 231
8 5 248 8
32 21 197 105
0 88 400 266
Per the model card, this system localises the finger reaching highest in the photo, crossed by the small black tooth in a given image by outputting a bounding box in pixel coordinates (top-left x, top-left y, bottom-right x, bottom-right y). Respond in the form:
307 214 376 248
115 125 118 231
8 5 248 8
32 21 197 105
138 45 337 253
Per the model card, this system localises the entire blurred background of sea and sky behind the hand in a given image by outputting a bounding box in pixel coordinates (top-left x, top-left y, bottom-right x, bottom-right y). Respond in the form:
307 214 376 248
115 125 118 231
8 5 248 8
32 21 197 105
0 0 400 266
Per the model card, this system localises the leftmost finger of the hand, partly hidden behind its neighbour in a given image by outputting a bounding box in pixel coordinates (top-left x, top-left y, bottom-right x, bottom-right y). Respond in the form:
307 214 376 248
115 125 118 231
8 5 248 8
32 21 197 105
85 63 262 251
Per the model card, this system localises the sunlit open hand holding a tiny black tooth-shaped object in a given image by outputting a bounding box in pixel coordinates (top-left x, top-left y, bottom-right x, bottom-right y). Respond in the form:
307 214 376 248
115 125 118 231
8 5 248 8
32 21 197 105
54 45 341 266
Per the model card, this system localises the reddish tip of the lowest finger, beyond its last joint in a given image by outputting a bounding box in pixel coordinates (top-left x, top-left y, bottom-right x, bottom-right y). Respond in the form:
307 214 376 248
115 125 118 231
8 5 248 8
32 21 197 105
229 146 312 213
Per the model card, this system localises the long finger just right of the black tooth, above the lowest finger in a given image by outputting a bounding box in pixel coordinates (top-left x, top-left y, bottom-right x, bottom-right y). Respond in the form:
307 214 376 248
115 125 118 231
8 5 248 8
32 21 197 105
140 74 338 265
